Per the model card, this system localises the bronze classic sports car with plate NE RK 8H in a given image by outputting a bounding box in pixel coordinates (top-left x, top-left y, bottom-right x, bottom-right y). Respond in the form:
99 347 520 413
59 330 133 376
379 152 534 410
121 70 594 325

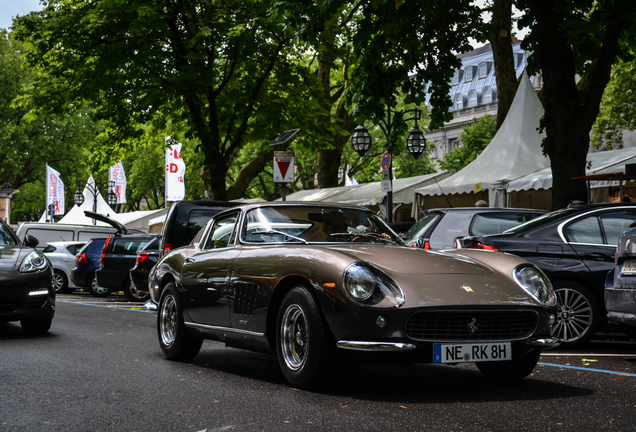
149 202 559 386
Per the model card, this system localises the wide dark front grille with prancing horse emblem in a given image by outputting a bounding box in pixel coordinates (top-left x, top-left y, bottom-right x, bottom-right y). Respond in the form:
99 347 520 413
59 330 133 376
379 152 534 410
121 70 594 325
406 310 539 342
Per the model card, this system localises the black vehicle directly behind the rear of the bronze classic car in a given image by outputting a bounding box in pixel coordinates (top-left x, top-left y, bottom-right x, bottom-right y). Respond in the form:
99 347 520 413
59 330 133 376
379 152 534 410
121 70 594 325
159 200 238 256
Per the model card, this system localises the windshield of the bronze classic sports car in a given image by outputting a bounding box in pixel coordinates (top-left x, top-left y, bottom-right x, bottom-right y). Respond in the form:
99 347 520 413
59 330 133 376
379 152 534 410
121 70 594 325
241 205 405 245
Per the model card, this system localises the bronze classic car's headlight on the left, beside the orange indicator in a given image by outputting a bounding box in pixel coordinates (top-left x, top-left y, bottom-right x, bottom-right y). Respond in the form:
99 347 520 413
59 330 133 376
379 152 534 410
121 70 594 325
342 262 405 308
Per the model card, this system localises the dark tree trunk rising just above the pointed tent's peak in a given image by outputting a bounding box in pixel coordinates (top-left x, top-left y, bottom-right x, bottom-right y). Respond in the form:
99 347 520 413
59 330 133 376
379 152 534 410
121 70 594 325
490 0 518 130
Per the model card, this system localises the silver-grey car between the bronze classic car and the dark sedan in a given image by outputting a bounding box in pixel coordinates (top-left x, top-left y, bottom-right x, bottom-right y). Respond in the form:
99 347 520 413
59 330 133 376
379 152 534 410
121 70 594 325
402 207 547 249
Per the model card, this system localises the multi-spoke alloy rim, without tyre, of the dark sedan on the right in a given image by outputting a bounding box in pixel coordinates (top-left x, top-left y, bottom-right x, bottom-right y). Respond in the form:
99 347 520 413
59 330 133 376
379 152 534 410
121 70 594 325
552 288 594 342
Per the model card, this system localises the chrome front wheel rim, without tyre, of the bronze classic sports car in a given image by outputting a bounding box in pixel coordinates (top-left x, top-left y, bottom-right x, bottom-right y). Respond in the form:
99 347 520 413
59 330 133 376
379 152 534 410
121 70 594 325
280 305 308 371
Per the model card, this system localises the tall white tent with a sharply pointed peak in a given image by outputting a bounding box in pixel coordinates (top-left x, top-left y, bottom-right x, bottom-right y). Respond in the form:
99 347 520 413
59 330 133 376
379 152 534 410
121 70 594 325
415 73 550 214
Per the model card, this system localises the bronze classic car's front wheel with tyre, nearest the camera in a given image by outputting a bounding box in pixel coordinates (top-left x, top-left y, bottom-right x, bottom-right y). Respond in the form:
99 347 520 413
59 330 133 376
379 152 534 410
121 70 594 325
276 286 331 387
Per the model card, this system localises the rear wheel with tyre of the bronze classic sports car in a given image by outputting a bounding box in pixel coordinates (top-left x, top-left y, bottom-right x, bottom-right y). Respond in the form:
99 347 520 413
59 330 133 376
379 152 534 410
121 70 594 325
157 283 203 361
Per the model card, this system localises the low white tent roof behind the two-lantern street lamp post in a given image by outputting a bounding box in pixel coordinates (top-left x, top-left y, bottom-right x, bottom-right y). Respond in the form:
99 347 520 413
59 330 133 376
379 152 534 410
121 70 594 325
287 171 450 216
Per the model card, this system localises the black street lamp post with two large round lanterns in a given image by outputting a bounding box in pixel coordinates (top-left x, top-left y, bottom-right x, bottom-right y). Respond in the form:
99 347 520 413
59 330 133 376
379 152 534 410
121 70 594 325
351 107 426 223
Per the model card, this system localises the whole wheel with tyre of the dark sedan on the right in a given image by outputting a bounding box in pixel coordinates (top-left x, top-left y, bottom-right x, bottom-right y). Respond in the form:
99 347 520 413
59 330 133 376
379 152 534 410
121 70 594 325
552 282 601 348
